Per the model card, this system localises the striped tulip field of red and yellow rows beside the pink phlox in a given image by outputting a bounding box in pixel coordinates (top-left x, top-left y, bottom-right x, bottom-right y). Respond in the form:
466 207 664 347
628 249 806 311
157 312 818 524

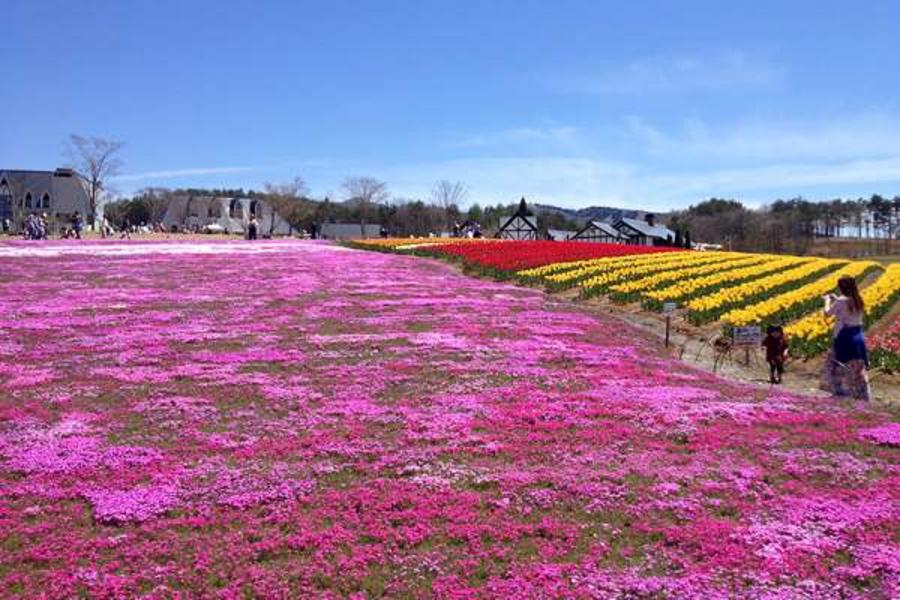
357 239 900 370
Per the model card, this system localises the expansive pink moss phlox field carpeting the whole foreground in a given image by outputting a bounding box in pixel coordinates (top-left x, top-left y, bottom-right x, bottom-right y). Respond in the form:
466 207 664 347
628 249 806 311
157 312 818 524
0 242 900 599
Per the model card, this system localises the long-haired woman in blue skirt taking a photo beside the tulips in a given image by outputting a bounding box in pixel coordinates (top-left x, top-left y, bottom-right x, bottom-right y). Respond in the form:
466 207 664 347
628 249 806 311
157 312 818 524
823 276 871 401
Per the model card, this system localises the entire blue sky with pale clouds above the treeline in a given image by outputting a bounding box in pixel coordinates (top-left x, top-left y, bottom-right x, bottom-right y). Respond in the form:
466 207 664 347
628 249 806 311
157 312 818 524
0 0 900 210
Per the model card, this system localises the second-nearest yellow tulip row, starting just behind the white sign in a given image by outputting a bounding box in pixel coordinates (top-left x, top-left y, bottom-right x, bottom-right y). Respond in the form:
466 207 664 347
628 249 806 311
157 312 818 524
720 260 879 327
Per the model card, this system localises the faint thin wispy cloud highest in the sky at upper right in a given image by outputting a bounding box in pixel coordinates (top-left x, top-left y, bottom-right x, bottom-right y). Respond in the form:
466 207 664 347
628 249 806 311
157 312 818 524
555 50 786 95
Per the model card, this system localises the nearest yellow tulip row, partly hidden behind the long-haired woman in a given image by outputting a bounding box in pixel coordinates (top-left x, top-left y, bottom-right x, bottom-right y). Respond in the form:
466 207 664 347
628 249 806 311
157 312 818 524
784 264 900 356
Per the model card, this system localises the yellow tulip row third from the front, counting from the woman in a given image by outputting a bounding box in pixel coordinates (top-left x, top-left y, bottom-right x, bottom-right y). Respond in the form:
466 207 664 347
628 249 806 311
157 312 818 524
687 258 847 324
